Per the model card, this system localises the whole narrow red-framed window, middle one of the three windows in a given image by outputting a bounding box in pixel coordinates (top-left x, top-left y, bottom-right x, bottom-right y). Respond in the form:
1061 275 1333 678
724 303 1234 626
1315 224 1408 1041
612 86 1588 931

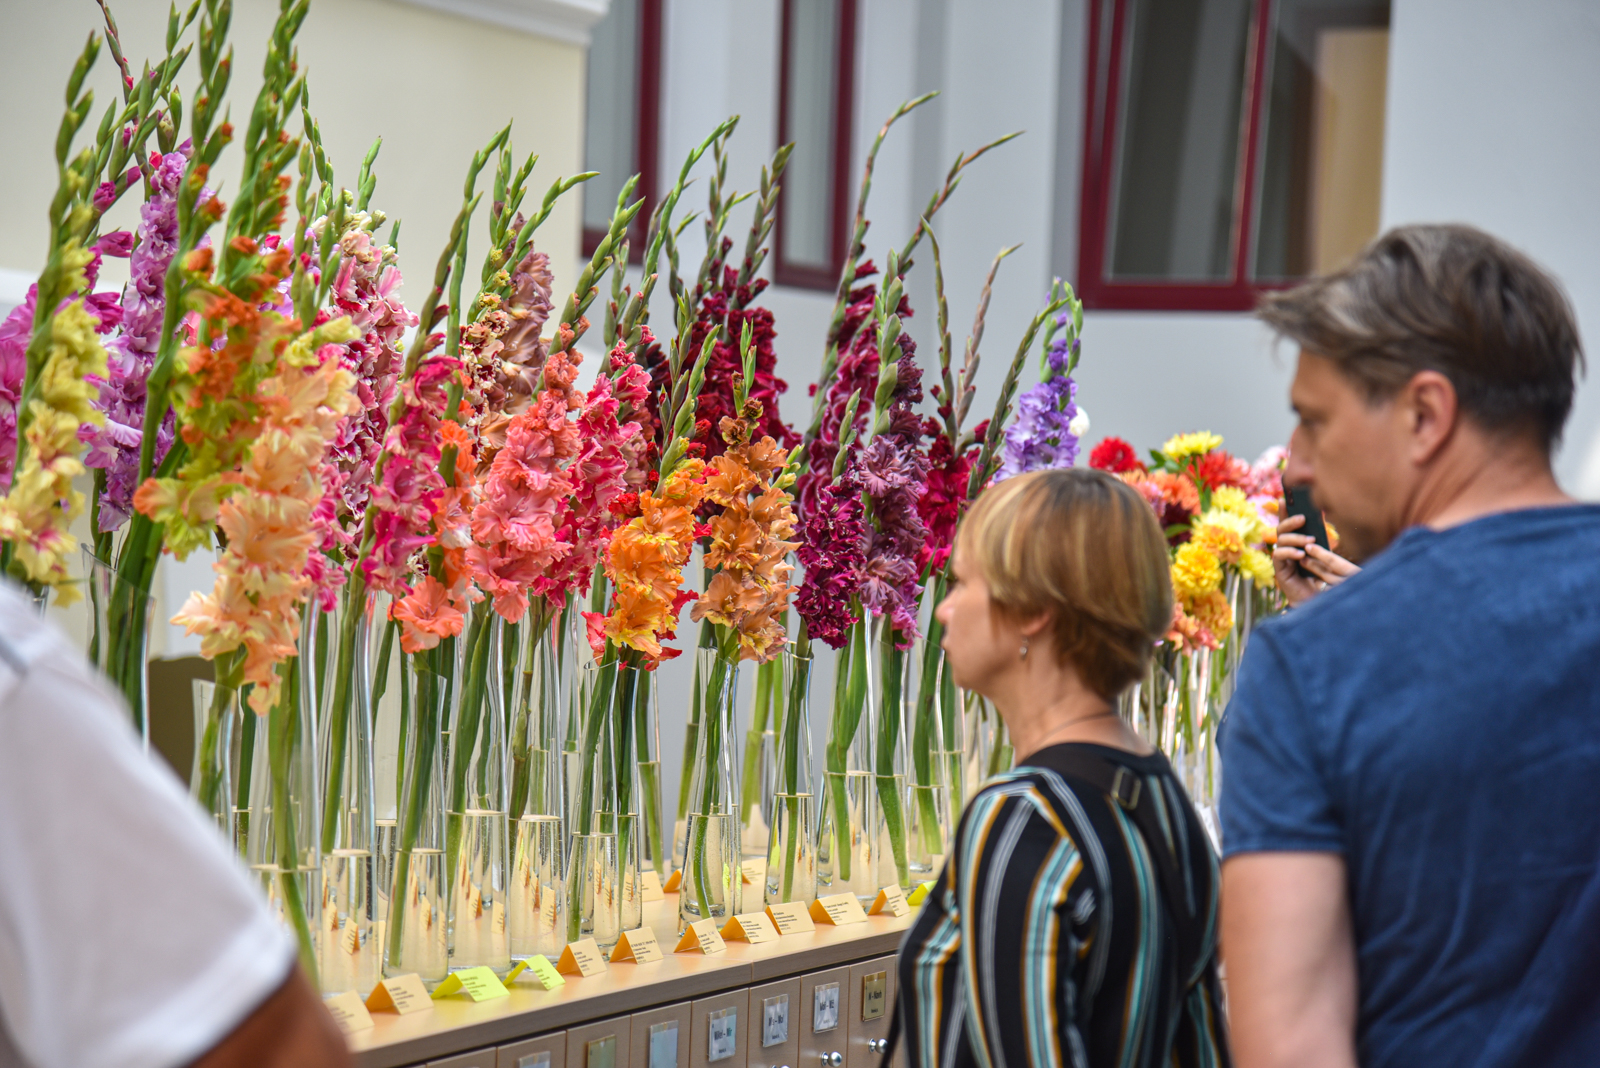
773 0 856 289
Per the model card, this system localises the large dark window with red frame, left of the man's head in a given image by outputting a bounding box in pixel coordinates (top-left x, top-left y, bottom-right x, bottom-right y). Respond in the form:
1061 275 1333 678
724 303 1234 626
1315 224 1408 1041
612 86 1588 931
1078 0 1389 310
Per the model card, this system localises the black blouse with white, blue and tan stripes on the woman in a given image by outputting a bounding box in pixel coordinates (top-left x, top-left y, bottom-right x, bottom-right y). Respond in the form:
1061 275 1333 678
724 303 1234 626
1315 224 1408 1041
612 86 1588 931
898 743 1230 1068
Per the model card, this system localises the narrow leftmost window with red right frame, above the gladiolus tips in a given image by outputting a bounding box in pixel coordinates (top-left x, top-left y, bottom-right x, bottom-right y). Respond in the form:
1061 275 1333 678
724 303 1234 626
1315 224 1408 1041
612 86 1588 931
582 0 661 255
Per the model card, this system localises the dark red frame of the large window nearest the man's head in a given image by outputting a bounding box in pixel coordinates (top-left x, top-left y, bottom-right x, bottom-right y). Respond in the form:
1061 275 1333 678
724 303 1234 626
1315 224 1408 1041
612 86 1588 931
1077 0 1294 312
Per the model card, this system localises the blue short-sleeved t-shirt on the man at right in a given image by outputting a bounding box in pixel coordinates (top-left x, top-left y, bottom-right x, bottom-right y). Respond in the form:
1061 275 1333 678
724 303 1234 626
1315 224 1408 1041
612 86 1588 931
1221 505 1600 1068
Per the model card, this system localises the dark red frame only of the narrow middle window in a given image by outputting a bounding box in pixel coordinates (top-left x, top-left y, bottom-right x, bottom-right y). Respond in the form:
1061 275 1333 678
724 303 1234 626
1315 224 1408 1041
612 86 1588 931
773 0 856 291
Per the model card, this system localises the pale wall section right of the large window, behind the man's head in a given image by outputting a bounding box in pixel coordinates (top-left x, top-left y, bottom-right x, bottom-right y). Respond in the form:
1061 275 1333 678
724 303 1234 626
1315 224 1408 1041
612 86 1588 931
1382 0 1600 499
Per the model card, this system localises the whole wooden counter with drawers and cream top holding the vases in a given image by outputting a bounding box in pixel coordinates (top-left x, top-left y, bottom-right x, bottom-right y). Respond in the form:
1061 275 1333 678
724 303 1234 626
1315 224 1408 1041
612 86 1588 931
349 894 915 1068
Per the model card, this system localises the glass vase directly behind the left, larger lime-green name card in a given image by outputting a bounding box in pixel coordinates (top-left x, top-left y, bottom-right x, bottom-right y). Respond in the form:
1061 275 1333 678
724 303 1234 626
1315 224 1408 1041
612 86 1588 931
445 601 515 975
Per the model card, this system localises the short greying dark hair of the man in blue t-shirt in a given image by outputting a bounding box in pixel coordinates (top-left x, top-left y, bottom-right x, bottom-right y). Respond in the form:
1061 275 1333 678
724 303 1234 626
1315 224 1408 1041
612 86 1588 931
1256 225 1584 449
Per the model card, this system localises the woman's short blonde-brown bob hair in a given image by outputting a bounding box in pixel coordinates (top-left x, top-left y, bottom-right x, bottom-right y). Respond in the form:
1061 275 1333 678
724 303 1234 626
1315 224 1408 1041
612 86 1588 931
955 467 1173 700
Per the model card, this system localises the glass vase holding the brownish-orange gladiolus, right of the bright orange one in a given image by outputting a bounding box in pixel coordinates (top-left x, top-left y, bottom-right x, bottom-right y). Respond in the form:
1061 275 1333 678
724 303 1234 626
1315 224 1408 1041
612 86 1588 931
678 648 744 927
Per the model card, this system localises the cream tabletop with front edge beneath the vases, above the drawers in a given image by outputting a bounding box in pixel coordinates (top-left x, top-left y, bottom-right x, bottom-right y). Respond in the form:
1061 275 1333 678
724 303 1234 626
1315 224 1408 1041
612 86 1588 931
349 887 915 1068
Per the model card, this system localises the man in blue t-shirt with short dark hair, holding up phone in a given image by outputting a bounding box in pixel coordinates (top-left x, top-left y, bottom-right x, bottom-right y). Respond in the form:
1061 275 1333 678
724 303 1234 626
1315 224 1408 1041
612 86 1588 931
1221 225 1600 1068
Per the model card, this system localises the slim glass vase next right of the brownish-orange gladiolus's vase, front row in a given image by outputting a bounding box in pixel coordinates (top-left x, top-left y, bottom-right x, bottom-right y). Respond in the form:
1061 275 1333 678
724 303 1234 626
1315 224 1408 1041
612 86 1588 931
763 640 816 905
